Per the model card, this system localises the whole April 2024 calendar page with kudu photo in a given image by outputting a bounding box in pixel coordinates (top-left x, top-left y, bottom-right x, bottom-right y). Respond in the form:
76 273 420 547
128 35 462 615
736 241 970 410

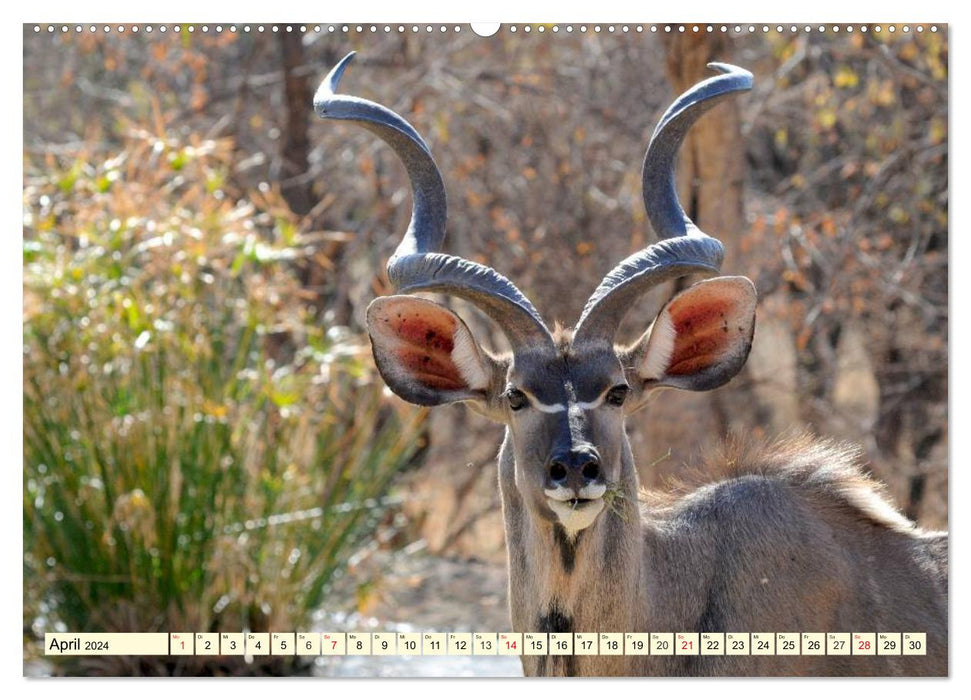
22 8 950 679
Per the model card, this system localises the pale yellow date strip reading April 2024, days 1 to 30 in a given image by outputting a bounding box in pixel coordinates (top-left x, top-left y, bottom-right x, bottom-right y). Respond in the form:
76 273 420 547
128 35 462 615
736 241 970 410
44 632 927 656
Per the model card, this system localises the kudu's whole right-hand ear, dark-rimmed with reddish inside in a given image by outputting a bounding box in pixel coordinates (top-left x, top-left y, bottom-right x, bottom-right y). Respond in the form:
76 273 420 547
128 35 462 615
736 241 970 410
627 277 756 391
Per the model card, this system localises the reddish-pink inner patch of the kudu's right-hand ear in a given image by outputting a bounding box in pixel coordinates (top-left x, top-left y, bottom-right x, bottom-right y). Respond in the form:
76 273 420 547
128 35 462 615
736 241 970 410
666 293 744 375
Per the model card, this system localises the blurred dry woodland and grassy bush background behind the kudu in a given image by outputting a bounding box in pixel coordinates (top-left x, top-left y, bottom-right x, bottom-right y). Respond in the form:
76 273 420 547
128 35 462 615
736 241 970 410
23 25 948 675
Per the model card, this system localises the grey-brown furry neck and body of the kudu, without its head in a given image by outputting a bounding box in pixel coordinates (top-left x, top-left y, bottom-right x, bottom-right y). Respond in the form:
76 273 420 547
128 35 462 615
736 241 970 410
499 434 947 676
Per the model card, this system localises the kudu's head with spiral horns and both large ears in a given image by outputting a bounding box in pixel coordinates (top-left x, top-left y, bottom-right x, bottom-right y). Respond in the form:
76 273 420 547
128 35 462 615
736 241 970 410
314 53 756 535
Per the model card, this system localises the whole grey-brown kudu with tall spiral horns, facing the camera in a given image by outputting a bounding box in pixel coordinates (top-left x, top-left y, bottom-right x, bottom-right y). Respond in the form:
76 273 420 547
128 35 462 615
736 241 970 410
314 54 948 676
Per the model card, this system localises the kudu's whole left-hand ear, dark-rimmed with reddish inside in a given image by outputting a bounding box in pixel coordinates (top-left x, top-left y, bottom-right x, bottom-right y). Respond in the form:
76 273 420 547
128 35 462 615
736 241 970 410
367 295 495 406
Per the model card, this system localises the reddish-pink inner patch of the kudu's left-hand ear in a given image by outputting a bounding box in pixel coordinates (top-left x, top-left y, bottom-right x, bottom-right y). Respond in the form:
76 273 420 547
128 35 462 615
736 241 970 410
379 307 466 391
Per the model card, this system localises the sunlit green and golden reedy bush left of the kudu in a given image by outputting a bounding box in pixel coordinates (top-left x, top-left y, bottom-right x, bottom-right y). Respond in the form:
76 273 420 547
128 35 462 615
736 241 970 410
23 120 420 672
